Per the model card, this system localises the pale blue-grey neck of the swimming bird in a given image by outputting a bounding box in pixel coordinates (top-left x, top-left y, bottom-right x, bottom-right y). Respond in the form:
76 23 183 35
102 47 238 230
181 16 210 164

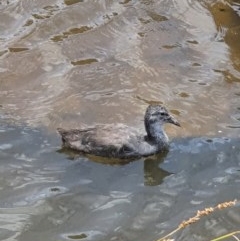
145 122 168 145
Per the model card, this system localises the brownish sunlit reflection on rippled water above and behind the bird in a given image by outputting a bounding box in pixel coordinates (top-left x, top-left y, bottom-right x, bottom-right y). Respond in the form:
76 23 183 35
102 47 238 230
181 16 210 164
0 0 239 136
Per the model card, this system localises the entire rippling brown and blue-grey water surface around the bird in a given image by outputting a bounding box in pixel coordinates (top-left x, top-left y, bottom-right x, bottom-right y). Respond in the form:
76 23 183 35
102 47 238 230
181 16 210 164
0 0 240 240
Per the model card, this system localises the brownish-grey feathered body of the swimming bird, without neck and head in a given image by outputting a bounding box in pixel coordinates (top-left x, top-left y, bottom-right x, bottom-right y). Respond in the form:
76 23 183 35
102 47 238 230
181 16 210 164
58 124 144 158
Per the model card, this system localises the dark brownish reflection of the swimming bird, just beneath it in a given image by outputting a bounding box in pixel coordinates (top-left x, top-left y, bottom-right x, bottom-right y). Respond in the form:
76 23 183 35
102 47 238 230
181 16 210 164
57 148 172 186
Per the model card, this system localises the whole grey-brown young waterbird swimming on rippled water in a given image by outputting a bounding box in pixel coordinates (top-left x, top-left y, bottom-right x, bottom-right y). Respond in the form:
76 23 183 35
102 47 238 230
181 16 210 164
57 104 180 159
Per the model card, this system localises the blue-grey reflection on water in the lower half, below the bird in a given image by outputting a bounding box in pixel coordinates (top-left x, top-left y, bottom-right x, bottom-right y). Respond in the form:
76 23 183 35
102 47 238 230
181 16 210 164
0 125 240 240
